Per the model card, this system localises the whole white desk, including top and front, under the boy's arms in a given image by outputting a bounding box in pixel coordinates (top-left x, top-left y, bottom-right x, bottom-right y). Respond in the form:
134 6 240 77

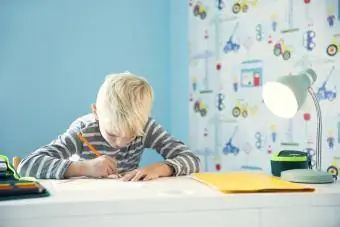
0 177 340 227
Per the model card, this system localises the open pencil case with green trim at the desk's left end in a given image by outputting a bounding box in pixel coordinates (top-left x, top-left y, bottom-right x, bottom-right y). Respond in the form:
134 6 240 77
0 155 49 201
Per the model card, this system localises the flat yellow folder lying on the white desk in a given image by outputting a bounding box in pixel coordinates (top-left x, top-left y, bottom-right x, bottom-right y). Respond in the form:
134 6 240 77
192 171 315 193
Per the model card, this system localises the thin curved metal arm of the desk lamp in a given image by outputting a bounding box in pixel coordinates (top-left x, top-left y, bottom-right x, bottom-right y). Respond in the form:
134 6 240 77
308 87 322 171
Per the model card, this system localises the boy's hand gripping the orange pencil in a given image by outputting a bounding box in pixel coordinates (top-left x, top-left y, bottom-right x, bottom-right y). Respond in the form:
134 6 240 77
84 155 117 178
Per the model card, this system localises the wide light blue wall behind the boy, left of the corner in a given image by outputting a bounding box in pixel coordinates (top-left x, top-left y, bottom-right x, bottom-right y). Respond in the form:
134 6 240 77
0 0 170 163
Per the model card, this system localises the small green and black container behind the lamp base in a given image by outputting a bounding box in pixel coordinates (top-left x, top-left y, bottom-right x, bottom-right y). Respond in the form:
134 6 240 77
270 150 311 177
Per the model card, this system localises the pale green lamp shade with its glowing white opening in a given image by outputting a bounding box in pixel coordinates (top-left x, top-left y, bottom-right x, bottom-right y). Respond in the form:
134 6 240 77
262 69 317 118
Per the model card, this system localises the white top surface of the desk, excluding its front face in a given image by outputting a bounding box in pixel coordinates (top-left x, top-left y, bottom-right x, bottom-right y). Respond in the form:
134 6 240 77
0 177 340 216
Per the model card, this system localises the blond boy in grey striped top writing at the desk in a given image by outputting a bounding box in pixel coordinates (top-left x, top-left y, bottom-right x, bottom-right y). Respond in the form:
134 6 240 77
18 73 200 181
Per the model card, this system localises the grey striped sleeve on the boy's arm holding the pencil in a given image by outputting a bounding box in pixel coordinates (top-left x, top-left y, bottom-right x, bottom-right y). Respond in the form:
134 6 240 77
18 118 84 179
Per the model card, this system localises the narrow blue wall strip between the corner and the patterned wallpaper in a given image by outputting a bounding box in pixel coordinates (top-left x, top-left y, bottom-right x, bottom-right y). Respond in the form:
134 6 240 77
170 0 189 143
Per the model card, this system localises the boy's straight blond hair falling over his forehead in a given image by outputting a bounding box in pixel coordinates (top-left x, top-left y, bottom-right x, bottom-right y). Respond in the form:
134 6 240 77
96 72 153 137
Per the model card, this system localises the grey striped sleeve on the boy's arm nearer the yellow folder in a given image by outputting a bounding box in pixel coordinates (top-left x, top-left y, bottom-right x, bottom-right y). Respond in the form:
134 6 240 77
144 118 200 176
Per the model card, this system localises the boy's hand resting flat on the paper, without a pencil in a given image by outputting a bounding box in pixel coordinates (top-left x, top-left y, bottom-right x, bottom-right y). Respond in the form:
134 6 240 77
122 163 174 181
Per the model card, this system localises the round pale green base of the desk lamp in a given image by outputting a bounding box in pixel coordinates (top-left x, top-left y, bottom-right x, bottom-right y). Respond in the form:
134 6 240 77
281 169 334 184
